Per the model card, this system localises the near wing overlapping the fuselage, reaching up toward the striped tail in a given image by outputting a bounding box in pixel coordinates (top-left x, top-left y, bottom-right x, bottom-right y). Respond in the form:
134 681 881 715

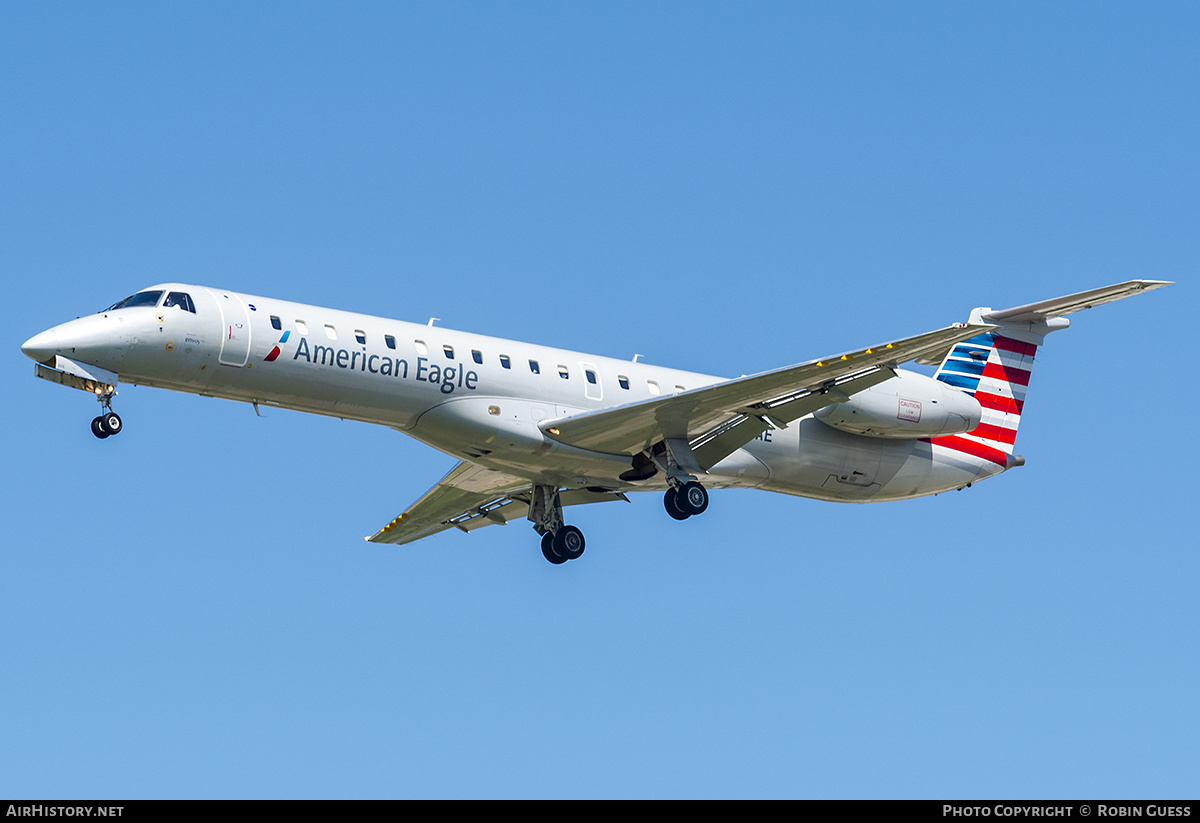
541 323 996 470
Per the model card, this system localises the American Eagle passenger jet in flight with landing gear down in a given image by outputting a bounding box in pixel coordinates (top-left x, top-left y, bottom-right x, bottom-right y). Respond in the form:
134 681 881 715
22 280 1170 564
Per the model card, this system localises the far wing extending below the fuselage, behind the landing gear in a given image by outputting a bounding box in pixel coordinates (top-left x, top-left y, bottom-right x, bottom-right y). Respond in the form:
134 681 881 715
367 461 626 546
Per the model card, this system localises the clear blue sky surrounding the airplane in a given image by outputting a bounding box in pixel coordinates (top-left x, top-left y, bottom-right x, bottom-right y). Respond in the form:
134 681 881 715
0 2 1200 798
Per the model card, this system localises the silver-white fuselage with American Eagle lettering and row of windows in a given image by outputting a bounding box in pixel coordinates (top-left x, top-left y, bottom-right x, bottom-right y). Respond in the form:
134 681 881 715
25 284 1004 503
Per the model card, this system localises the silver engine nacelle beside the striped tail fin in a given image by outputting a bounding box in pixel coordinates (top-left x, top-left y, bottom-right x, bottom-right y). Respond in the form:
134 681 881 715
812 371 983 438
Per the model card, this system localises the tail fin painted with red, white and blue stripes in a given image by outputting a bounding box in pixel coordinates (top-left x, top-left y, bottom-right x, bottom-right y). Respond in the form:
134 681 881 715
931 332 1038 467
